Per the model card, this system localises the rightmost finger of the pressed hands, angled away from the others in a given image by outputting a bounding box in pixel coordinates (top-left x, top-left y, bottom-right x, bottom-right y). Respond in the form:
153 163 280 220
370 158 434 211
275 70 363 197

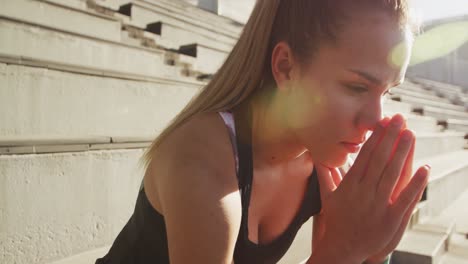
391 166 430 217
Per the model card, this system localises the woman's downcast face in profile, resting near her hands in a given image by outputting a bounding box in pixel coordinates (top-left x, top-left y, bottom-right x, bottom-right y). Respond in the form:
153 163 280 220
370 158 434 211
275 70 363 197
284 12 411 167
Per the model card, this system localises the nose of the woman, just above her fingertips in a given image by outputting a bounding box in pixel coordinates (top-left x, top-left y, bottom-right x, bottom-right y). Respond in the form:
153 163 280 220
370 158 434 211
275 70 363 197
356 98 383 132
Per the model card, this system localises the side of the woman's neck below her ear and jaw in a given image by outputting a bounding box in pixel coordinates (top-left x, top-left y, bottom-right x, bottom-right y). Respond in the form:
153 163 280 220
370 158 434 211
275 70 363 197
251 91 306 167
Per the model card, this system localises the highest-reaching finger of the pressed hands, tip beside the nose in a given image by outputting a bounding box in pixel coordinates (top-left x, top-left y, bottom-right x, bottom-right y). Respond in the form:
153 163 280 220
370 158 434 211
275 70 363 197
363 114 405 190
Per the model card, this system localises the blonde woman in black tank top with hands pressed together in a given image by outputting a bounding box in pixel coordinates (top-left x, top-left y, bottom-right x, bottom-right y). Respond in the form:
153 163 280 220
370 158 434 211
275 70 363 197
97 0 429 264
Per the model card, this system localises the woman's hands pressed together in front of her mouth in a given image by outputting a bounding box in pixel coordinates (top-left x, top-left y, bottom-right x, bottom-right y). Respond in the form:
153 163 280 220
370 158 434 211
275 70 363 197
312 115 430 263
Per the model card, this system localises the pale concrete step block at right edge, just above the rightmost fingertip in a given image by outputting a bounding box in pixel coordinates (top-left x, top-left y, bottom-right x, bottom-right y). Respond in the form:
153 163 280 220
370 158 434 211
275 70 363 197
414 131 465 159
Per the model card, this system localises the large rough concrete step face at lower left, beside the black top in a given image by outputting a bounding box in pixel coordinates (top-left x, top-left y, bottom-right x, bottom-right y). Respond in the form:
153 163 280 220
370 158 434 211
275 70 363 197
0 149 144 264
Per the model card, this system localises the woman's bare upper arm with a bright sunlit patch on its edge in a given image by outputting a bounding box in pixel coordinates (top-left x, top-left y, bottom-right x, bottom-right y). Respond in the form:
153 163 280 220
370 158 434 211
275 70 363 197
154 114 242 264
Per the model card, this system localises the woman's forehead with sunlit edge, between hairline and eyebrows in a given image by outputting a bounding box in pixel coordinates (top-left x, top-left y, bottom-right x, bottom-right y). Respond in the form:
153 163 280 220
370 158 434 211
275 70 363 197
317 11 411 82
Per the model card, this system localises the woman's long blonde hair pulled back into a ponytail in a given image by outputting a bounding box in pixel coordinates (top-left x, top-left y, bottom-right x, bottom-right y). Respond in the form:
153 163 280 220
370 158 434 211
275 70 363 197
143 0 407 167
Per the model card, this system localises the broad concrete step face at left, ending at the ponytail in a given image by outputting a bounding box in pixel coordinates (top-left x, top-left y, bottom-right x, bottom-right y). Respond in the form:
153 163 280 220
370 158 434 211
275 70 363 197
0 63 201 136
